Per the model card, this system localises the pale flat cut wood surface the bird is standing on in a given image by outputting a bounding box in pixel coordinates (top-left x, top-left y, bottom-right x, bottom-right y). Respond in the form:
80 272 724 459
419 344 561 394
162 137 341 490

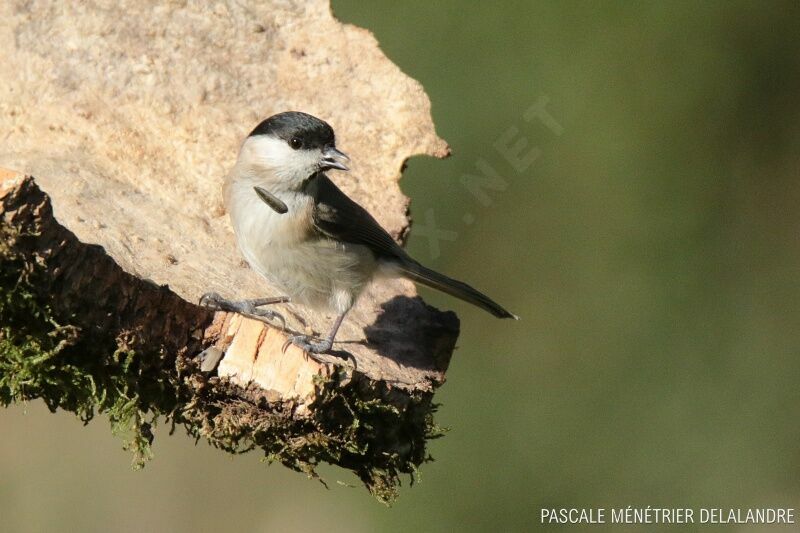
0 0 457 404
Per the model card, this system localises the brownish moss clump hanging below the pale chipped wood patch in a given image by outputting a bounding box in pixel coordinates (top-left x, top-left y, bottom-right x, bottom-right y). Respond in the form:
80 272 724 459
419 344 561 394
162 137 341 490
174 361 442 504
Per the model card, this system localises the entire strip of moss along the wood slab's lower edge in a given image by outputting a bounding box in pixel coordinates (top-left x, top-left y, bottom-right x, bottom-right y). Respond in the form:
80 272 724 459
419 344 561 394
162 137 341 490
0 217 442 503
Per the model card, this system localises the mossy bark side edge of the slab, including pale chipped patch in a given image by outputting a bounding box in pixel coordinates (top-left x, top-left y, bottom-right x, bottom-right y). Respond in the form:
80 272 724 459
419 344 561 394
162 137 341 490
0 172 458 501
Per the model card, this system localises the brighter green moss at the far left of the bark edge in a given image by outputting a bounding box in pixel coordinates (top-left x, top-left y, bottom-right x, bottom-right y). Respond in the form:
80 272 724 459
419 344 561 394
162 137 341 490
0 227 167 466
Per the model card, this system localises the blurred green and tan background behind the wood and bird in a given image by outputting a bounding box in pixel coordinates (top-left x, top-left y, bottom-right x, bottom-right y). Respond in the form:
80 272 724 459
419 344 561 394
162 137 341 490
0 0 800 532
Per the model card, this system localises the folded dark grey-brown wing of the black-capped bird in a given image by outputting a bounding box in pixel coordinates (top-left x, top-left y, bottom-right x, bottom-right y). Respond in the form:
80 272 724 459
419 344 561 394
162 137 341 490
306 173 410 260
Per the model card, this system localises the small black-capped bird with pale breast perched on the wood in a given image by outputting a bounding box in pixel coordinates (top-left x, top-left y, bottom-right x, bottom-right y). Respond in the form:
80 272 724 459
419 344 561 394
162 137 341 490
201 111 518 354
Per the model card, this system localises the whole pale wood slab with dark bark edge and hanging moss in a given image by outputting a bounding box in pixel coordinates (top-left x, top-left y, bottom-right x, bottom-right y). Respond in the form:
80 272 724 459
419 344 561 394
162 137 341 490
0 0 458 501
